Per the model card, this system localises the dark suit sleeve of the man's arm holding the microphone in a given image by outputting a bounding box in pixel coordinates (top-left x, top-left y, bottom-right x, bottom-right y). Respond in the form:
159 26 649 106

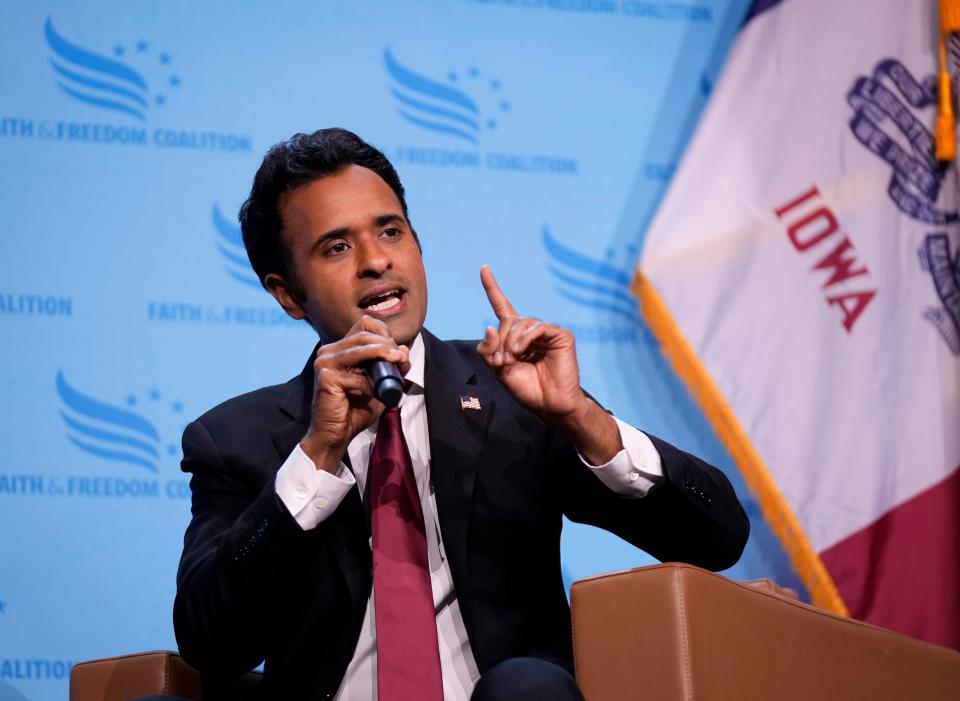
173 420 311 676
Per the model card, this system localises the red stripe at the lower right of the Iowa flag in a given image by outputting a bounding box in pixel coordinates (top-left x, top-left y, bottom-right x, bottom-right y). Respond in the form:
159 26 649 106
821 469 960 650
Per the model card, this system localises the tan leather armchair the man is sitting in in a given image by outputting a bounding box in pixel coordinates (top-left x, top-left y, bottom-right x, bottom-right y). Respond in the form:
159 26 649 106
70 564 960 701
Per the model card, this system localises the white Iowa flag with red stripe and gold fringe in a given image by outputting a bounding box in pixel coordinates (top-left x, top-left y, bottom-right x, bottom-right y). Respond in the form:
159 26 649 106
635 0 960 648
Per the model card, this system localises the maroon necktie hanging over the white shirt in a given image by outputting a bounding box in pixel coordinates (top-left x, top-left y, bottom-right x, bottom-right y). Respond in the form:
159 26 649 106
370 407 443 701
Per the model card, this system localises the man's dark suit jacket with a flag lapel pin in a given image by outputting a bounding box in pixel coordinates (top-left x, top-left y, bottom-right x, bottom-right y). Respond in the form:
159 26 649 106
174 331 749 698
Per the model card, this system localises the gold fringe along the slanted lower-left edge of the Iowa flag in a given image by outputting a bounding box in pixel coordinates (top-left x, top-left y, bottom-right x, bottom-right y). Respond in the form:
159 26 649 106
632 273 850 616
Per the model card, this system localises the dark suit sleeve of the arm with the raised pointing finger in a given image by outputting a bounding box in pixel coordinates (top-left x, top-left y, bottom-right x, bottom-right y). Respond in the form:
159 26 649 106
561 434 750 570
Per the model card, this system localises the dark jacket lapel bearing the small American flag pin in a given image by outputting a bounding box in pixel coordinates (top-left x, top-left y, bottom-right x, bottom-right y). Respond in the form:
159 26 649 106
423 330 495 600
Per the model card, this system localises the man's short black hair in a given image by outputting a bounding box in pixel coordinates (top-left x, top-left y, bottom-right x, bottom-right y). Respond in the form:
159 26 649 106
240 128 410 297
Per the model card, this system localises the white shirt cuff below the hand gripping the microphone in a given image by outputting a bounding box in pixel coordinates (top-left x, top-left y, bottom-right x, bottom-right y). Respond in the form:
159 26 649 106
274 443 357 531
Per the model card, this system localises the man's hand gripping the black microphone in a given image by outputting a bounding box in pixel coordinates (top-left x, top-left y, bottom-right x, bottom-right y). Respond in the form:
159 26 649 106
300 316 410 472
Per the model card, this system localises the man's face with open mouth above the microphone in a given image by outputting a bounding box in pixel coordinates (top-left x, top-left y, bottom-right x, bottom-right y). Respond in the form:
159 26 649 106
267 165 427 345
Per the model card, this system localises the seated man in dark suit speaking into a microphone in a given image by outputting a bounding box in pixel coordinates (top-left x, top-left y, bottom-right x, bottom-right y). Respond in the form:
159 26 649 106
174 129 749 701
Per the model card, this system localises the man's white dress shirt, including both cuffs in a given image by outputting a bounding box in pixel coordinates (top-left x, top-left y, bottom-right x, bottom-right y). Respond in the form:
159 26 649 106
275 335 663 701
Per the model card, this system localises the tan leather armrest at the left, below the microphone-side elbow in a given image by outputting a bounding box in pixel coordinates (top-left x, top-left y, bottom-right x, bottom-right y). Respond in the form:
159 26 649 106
70 651 202 701
